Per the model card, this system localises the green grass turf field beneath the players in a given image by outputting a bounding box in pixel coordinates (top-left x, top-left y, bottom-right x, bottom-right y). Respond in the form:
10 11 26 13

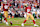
0 17 40 26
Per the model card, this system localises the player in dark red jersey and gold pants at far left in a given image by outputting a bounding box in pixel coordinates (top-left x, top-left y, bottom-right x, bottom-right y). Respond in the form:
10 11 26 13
1 0 9 25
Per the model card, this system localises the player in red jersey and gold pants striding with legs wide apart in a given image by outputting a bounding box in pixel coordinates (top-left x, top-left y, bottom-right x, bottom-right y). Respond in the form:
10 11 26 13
21 5 38 26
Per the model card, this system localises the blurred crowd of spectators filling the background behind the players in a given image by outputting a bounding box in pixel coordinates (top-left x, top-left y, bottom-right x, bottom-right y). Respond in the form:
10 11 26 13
0 0 40 17
